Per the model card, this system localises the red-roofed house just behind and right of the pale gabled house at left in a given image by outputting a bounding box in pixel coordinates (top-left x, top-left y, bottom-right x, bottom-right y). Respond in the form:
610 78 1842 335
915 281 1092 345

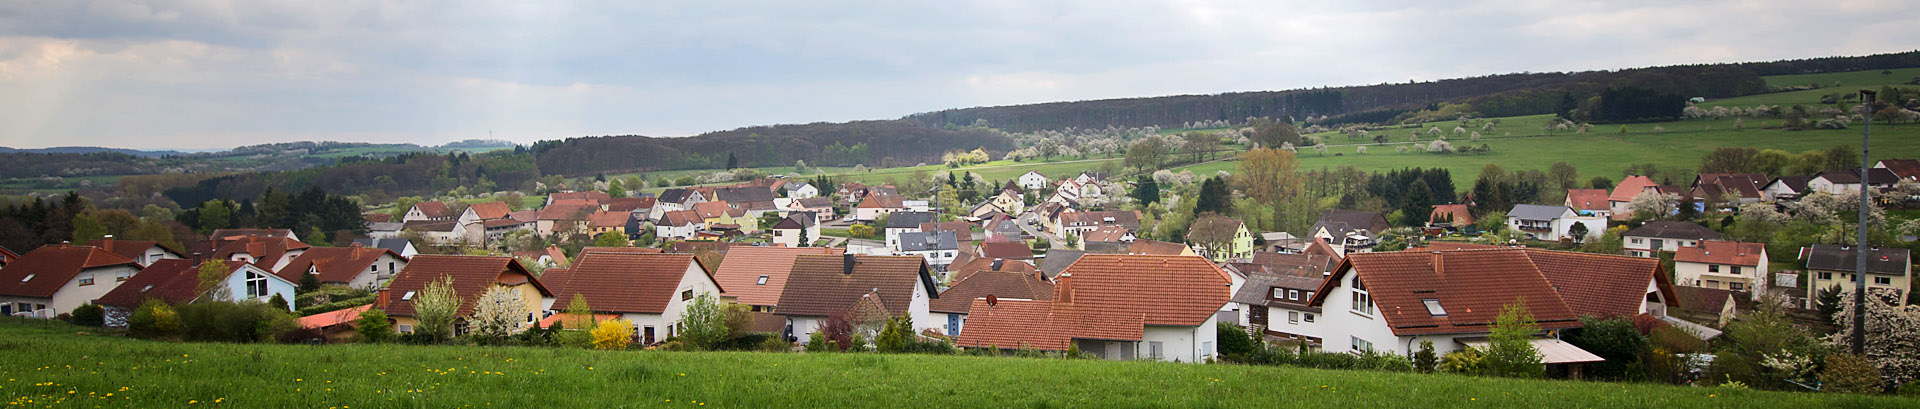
275 244 407 290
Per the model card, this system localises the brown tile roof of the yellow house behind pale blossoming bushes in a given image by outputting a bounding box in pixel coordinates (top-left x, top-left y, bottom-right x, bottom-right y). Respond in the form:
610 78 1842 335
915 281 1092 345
378 253 553 317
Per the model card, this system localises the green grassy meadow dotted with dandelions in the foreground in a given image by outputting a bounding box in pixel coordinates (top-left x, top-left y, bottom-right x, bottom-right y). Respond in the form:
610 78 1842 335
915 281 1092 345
0 319 1916 409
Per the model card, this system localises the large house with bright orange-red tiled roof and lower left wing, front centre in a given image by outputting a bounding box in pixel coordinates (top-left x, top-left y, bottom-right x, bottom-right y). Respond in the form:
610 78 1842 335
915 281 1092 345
956 253 1233 363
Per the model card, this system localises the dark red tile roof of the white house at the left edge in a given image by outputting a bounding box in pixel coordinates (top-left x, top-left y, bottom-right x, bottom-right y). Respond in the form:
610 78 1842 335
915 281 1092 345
0 244 132 298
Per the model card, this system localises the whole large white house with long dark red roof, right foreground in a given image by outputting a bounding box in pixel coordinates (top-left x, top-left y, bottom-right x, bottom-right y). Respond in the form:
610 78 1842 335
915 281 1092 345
1308 248 1676 359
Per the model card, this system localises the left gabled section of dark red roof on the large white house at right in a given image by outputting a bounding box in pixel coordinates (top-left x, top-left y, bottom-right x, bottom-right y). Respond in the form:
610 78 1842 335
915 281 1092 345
1309 250 1582 336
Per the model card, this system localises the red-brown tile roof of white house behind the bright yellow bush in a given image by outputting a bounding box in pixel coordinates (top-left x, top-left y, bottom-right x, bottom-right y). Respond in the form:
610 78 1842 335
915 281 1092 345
547 252 707 313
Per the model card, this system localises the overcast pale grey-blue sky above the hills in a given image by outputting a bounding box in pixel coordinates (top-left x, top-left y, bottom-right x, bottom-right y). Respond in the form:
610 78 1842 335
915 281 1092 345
0 0 1920 150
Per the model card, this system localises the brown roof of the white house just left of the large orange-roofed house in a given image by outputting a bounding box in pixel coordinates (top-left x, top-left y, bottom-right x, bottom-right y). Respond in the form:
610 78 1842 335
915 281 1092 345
774 255 939 317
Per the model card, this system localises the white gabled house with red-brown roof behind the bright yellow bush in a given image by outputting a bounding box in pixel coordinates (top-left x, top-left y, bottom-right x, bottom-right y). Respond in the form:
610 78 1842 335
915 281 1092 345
540 252 722 346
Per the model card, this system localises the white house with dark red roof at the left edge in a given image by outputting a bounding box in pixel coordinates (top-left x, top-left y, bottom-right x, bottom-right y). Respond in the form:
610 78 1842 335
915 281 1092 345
0 244 140 319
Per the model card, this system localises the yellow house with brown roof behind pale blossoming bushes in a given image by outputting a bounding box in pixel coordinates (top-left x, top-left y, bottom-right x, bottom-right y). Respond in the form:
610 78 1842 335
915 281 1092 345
374 253 553 336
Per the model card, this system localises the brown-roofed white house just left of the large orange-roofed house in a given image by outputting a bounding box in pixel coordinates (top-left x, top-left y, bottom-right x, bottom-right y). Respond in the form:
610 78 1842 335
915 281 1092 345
774 253 939 344
